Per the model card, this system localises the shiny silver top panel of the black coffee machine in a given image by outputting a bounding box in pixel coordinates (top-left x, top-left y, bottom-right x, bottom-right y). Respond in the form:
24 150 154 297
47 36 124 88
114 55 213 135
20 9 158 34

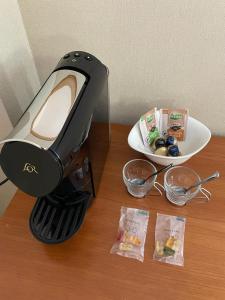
1 69 87 149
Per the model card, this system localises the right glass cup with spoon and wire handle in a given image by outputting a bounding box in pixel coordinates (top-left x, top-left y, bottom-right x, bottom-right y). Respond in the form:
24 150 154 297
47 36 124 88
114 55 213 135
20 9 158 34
164 166 211 206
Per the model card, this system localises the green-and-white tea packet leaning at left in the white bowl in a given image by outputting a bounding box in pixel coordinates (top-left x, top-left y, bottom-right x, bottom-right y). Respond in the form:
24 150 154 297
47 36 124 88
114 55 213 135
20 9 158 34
139 107 159 146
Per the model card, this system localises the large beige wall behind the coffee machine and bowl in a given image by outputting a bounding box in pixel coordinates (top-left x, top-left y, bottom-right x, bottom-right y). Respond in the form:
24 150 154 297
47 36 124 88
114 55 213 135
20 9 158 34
19 0 225 134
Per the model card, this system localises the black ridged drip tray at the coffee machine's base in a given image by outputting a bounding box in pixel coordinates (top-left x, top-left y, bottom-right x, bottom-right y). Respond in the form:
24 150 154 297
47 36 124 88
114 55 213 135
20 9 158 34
30 192 91 244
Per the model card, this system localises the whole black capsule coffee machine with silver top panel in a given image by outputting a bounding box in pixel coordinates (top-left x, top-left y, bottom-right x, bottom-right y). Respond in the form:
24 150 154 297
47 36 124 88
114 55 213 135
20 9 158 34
0 51 110 244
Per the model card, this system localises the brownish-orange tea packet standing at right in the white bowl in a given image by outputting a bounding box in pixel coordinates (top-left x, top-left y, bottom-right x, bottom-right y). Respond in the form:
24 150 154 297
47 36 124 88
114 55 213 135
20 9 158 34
160 109 188 141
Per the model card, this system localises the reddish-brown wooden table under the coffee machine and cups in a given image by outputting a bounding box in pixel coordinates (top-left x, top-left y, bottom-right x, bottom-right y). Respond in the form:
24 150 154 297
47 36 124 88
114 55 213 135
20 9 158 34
0 125 225 300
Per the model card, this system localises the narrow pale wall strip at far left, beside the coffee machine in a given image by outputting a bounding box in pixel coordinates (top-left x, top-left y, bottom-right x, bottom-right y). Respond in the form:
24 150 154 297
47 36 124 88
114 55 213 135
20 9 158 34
0 0 40 214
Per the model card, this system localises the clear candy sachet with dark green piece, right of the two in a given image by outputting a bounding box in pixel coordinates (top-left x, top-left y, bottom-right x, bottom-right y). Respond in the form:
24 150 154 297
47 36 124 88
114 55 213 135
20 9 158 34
153 213 186 266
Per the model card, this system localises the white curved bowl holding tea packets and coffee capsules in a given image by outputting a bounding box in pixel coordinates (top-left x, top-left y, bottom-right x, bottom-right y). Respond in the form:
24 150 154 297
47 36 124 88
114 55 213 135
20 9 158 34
128 113 211 166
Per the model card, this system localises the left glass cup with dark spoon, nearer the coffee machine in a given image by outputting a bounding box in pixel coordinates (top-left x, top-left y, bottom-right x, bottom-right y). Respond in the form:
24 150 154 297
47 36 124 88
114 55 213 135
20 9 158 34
123 159 164 198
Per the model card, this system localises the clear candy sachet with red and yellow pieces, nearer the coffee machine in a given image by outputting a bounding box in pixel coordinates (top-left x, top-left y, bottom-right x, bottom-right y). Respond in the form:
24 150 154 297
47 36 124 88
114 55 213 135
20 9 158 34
110 207 149 262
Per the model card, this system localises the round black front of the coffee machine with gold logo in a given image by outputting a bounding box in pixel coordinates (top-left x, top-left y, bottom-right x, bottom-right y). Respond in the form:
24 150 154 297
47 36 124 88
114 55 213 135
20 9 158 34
0 141 62 197
